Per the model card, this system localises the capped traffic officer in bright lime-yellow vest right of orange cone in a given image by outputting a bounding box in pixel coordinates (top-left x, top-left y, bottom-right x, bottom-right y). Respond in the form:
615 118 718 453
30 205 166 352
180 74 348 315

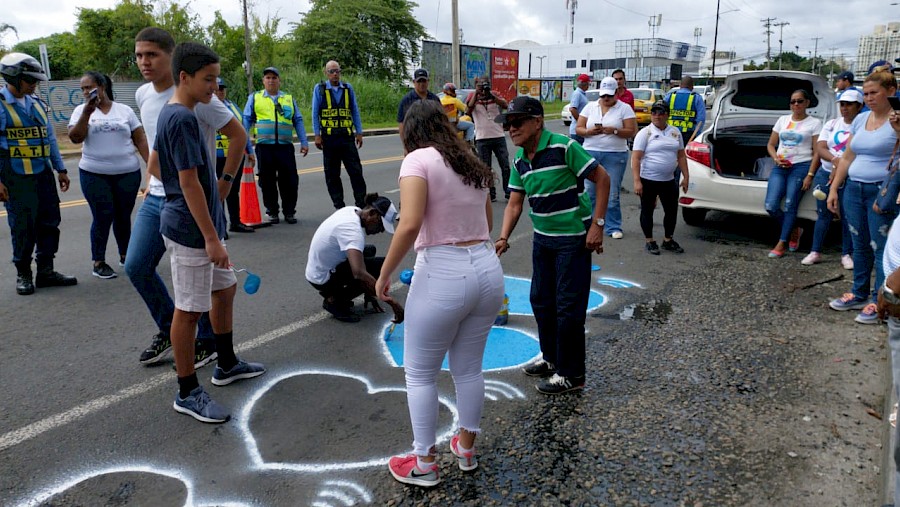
244 67 309 224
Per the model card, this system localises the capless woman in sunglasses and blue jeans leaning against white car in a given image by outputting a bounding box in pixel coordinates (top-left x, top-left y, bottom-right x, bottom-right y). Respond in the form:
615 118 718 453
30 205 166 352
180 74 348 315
766 90 822 259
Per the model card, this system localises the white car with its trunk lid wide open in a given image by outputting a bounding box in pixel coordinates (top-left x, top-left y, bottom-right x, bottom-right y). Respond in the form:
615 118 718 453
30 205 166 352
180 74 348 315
678 70 837 226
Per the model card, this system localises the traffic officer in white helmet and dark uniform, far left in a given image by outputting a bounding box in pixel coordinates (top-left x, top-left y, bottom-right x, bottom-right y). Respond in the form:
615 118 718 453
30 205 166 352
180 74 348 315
0 53 78 296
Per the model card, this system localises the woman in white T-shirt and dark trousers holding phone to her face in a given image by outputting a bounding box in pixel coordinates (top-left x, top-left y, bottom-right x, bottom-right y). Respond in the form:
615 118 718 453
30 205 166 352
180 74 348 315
69 71 148 279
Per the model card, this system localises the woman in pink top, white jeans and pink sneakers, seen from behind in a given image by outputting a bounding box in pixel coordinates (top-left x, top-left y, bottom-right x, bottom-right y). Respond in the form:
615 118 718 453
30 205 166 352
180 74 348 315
375 101 503 487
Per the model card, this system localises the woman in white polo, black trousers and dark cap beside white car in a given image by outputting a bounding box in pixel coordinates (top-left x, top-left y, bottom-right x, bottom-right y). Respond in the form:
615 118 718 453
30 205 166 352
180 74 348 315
631 101 690 255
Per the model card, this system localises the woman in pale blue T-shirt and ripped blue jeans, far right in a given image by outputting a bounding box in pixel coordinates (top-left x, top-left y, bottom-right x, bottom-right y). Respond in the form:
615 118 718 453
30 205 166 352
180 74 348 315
828 71 900 324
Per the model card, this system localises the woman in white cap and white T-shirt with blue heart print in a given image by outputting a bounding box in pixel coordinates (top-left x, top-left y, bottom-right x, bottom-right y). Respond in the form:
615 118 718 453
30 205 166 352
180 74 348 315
800 88 863 269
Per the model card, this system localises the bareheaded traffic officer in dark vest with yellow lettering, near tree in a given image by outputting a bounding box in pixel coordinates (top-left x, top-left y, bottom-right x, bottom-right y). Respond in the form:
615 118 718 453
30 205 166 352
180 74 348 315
312 60 366 209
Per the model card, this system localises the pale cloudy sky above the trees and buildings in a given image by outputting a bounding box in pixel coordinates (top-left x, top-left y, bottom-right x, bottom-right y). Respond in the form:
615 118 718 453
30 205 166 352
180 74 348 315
0 0 900 65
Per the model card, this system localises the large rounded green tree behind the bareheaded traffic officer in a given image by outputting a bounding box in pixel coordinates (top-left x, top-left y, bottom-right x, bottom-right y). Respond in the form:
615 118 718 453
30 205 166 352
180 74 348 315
292 0 427 83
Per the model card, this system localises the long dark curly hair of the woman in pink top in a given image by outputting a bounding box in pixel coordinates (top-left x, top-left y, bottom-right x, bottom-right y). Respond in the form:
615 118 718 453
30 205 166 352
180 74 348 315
402 100 494 188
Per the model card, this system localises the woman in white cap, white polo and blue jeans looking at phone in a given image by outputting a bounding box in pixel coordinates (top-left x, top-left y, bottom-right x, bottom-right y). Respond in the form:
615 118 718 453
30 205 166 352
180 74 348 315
575 77 637 239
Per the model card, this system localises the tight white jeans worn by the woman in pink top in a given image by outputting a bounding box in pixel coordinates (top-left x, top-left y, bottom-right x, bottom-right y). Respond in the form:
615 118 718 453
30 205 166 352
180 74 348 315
403 242 503 456
